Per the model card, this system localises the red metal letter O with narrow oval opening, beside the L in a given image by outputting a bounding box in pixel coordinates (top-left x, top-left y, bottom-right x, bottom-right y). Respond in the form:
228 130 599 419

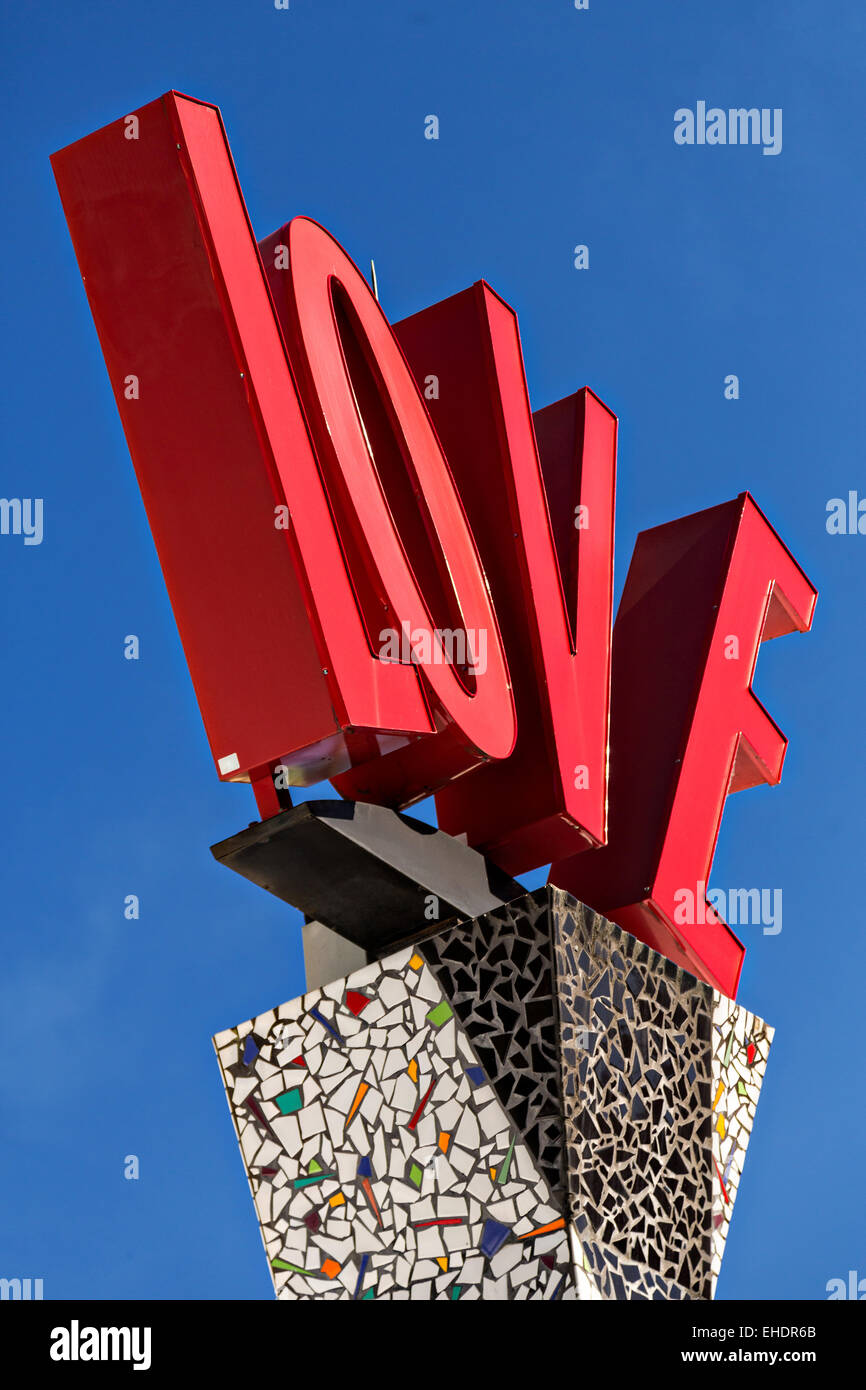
261 217 516 806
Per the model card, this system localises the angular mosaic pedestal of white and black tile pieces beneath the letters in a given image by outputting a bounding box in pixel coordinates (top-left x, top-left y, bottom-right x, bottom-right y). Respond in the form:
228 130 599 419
214 888 771 1301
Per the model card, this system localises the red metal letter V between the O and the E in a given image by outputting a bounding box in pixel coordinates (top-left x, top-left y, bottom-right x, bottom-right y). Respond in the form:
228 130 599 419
395 281 616 873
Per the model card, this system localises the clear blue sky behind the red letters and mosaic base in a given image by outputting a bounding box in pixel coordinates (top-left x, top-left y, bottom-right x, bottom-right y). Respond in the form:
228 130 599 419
0 0 866 1298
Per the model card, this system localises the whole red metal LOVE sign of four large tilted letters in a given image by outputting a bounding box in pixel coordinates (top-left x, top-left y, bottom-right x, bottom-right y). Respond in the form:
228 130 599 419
53 93 816 995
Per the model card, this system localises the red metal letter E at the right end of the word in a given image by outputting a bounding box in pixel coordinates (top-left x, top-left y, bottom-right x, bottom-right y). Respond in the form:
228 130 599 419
550 492 817 997
